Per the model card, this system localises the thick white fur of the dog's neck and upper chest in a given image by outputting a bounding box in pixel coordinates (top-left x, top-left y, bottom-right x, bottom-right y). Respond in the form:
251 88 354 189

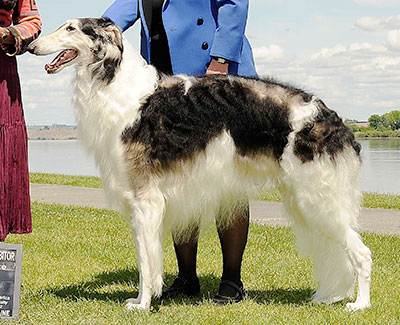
74 44 158 151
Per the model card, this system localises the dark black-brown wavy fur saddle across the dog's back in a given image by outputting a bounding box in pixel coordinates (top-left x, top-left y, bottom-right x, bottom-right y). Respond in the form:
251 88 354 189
122 77 360 169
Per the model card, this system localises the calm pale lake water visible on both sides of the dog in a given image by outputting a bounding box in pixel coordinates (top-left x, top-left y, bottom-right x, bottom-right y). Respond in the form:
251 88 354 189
29 139 400 194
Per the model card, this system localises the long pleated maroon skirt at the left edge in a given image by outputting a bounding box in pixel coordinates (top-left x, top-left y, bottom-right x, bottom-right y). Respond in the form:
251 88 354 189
0 51 32 241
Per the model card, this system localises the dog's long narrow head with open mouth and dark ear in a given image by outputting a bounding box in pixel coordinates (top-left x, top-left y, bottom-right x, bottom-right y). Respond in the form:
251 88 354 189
28 18 123 79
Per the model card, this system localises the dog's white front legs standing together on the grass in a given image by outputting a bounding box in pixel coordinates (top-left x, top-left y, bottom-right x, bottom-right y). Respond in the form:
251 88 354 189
126 188 165 310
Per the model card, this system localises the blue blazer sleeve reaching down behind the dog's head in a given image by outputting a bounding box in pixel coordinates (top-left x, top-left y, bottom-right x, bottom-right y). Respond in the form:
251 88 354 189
103 0 140 31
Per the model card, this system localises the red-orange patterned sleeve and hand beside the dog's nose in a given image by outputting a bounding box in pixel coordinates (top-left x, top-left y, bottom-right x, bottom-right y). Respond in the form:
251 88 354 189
6 0 42 56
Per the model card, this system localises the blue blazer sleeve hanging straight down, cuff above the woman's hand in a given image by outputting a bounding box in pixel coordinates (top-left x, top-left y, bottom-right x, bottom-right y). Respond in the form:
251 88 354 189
210 0 249 63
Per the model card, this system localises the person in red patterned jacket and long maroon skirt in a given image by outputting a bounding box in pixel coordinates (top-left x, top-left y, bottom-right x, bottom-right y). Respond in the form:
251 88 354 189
0 0 41 241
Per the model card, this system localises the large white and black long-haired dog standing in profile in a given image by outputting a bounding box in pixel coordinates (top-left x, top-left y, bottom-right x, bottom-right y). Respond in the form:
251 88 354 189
30 18 372 310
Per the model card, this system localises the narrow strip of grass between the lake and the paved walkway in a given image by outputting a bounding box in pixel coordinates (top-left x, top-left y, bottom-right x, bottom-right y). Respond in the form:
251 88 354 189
30 173 400 210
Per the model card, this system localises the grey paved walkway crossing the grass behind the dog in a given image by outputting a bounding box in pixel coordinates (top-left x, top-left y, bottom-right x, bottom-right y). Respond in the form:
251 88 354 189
31 184 400 235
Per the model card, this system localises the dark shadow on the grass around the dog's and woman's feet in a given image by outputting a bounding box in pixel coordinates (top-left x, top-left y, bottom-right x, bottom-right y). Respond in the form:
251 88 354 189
46 268 313 310
